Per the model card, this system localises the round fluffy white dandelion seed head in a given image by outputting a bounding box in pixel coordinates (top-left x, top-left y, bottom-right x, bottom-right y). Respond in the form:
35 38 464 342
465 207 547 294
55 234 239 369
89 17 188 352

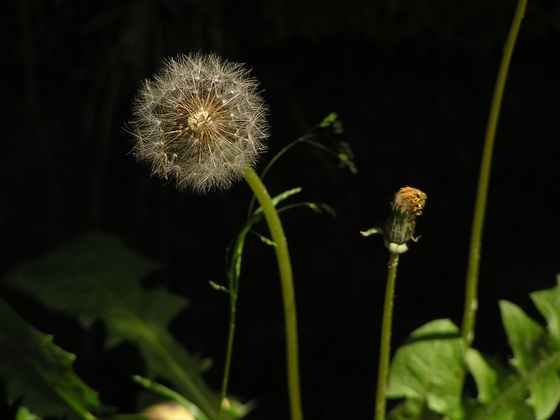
130 54 268 193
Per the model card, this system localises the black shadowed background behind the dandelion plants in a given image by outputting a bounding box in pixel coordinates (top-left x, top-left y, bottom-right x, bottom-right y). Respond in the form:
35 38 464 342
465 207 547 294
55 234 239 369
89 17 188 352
0 0 560 419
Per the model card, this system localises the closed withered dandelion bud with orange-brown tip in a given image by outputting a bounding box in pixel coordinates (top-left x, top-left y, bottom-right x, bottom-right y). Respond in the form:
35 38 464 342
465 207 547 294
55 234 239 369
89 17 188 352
385 187 427 254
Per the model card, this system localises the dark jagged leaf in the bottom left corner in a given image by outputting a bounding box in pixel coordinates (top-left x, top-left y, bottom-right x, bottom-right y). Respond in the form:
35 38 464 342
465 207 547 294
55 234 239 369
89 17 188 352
0 300 100 419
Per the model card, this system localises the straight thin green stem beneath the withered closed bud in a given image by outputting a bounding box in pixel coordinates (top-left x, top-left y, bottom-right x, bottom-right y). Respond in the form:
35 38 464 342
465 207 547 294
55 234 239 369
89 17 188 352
375 253 399 420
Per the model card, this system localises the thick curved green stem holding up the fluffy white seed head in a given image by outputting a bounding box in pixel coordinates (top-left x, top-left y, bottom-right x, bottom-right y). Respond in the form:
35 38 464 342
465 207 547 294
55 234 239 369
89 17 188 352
243 168 303 420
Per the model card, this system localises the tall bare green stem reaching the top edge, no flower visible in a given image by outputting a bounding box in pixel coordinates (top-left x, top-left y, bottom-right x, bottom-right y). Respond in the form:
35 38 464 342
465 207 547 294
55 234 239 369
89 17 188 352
461 0 527 348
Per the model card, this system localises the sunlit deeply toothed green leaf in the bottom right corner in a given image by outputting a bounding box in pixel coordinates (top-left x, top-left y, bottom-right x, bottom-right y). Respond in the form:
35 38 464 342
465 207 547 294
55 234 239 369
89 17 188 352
466 286 560 420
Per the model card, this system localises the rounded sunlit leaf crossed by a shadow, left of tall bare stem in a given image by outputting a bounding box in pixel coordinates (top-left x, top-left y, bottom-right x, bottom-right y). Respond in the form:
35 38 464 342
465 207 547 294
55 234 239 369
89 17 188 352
387 319 463 419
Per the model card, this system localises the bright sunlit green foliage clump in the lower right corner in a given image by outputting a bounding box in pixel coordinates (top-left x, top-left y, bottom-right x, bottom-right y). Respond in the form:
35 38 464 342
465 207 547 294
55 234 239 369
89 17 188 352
388 276 560 420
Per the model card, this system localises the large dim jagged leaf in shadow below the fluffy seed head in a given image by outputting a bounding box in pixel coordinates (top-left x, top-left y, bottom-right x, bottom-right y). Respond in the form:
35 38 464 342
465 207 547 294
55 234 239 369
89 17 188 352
6 233 224 416
